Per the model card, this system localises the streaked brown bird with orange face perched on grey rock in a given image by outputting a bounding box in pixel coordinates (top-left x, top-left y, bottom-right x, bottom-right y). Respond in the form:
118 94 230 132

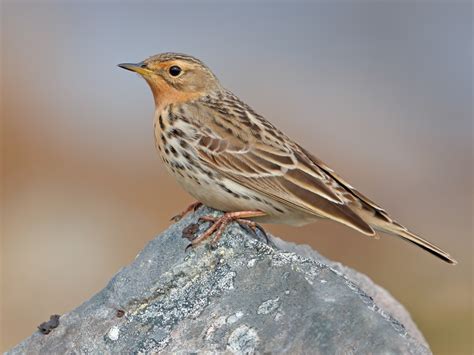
118 52 456 264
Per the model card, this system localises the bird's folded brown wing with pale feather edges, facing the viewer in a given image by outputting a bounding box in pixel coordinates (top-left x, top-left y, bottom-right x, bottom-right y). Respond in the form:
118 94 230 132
195 133 375 235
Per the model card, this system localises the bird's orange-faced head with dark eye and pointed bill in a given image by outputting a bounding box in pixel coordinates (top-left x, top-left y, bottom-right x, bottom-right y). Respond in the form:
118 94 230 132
118 53 220 108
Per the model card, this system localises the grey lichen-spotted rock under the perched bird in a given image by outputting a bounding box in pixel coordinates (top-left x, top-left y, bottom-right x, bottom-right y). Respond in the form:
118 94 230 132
8 208 431 354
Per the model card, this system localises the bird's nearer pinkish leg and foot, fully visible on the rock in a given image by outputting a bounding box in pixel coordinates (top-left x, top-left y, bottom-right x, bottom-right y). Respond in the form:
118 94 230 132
190 211 266 247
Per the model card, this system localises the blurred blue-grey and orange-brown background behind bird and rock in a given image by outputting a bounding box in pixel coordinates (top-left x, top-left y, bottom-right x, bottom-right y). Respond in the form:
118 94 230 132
0 0 473 354
